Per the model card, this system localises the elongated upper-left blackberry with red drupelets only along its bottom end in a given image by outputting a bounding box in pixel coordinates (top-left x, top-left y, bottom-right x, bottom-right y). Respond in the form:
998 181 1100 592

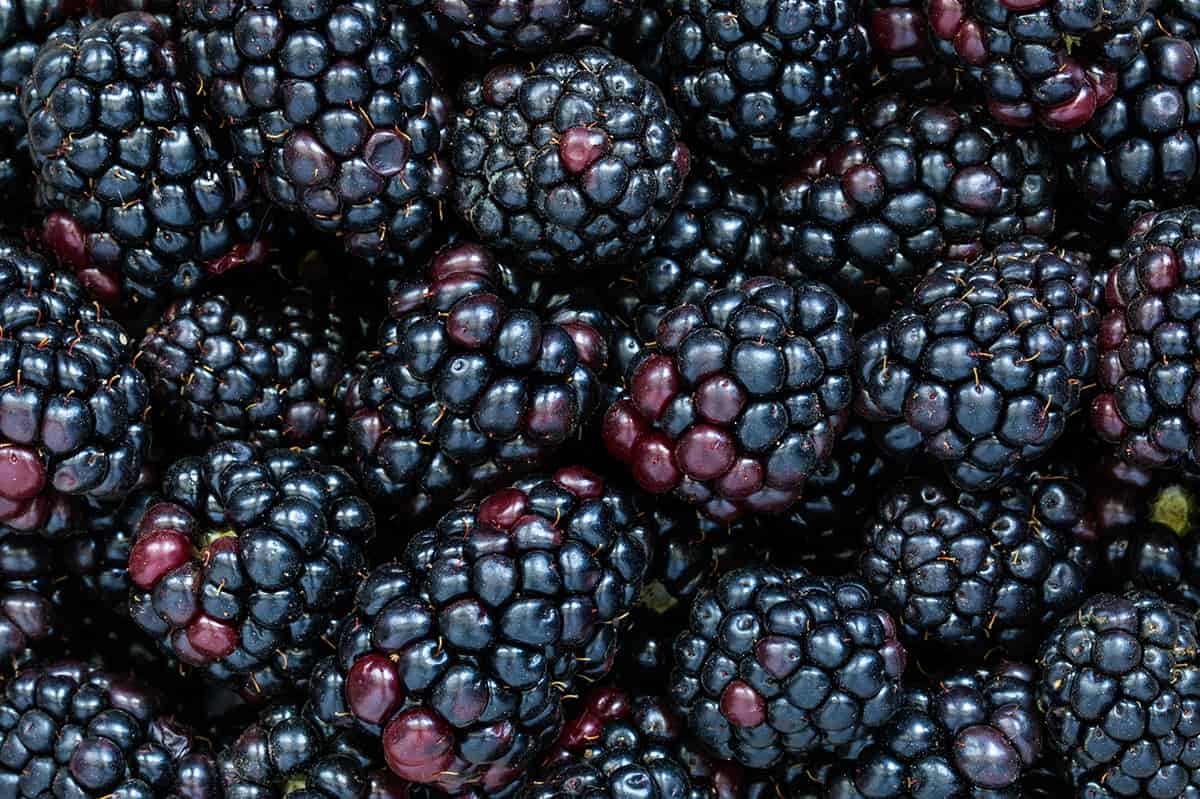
22 12 268 307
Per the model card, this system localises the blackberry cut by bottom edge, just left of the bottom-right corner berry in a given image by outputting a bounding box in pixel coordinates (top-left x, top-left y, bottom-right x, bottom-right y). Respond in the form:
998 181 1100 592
824 662 1041 799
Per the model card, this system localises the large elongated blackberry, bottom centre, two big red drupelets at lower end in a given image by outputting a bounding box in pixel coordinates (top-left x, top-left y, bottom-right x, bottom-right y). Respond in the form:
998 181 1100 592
310 467 652 795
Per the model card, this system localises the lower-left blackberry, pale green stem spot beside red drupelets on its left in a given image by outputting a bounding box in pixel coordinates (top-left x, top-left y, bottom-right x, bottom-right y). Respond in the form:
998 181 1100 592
128 441 374 698
